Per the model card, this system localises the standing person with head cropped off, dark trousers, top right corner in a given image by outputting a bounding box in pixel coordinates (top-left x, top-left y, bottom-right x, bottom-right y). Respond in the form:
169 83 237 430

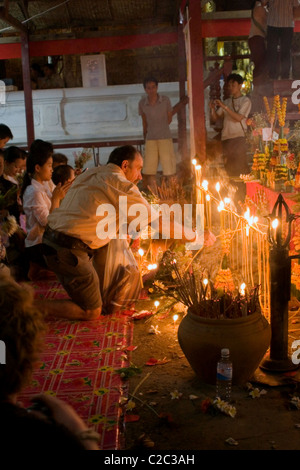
267 0 299 80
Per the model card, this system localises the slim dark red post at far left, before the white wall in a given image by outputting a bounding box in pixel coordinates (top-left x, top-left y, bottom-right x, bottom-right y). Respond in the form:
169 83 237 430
21 32 34 148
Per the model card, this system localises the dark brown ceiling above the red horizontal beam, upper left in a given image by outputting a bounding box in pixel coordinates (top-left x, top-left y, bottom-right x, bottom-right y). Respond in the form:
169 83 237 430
0 0 181 37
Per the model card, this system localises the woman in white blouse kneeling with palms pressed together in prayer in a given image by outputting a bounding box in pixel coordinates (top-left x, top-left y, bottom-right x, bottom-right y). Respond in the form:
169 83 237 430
22 140 71 280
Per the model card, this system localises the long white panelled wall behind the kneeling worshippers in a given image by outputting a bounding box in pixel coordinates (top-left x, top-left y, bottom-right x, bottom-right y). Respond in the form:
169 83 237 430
0 82 179 151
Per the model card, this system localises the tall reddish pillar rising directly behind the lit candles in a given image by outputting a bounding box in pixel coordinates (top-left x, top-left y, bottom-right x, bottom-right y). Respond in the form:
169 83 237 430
189 0 206 162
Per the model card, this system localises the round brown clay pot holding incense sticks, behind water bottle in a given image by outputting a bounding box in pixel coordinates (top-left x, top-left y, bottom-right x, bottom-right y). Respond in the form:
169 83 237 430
178 311 271 385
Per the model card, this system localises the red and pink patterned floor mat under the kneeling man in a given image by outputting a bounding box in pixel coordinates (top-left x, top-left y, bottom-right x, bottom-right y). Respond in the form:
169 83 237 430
19 281 133 450
